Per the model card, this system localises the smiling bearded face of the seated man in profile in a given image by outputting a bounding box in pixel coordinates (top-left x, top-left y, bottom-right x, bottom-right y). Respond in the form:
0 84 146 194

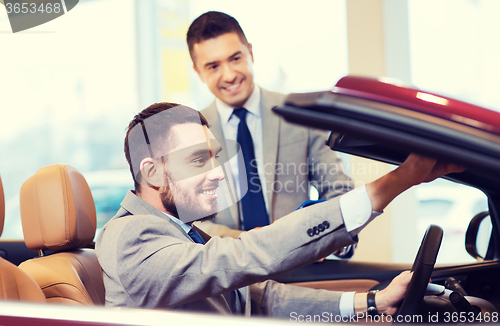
160 123 224 222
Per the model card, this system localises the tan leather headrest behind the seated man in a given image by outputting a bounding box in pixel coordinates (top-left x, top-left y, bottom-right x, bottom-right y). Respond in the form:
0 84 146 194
20 164 96 251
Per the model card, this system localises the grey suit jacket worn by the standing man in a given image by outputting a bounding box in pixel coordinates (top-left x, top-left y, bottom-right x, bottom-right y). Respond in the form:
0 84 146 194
196 88 353 238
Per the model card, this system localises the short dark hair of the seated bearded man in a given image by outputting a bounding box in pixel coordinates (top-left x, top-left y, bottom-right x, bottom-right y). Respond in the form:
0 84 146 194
125 102 209 193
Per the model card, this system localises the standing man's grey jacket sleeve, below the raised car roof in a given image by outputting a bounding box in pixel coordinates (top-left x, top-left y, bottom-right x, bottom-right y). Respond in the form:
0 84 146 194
308 128 354 199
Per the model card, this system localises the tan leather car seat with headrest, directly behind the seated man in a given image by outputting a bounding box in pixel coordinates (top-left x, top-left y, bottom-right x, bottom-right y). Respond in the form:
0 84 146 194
19 164 104 305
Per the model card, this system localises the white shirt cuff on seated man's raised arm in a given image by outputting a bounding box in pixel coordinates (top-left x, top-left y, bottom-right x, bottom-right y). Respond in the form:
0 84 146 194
340 185 382 236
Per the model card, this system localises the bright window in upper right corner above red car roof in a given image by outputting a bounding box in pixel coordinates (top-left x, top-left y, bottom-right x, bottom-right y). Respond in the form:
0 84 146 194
408 0 500 110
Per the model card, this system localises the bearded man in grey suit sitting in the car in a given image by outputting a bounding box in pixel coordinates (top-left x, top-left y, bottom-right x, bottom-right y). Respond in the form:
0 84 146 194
96 103 461 318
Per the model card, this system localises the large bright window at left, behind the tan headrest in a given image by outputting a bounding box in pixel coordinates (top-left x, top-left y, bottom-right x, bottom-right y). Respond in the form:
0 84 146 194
0 0 137 238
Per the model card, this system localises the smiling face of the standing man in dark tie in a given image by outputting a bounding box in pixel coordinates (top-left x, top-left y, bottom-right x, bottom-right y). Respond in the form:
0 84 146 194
193 33 254 107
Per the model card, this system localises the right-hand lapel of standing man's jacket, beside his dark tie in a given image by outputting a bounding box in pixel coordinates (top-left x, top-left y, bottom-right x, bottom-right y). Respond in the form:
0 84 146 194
261 88 280 222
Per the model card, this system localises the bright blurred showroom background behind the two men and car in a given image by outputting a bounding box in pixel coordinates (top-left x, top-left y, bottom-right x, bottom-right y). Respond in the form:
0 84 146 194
0 0 500 263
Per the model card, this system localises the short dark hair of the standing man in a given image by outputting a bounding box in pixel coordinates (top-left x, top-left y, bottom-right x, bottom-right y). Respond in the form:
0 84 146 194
186 11 248 63
